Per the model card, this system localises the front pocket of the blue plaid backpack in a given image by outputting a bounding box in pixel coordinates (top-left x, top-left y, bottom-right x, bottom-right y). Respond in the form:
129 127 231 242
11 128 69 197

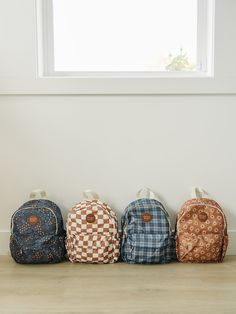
123 234 174 264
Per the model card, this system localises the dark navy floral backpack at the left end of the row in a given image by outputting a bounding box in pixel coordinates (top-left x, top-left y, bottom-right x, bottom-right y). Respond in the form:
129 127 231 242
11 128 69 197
10 190 66 264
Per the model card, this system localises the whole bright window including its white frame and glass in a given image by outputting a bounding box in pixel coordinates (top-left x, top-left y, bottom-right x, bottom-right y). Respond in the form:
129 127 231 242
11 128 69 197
38 0 213 77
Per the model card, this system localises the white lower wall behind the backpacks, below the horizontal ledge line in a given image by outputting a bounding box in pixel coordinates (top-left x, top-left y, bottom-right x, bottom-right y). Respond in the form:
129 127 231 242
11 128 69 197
0 96 236 254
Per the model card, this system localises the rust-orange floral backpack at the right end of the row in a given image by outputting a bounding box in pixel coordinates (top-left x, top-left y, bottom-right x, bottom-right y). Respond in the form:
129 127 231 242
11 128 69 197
176 188 228 263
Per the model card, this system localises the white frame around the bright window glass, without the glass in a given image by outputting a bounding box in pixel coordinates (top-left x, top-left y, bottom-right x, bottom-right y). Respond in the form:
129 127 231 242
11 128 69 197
36 0 215 80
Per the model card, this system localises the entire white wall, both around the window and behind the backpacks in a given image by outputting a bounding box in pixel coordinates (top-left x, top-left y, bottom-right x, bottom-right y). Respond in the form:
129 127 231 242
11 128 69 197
0 0 236 254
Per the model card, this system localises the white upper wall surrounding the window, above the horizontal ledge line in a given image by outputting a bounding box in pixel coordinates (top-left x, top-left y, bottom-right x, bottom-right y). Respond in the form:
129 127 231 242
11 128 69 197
0 0 236 94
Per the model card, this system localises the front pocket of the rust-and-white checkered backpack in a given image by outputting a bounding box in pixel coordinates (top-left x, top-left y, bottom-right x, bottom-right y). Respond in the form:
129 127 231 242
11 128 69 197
66 234 114 263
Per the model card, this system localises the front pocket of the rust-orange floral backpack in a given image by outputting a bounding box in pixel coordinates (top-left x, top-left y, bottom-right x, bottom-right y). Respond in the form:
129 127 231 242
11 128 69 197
178 233 223 263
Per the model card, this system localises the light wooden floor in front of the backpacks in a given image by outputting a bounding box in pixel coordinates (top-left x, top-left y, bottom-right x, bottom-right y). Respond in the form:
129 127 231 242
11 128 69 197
0 256 236 314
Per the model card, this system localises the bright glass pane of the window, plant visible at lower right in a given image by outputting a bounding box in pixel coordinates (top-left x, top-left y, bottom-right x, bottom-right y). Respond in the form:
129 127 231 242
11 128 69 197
53 0 197 71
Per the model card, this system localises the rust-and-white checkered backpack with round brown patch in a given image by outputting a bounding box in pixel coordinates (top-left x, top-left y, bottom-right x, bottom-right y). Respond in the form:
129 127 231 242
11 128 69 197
66 190 120 264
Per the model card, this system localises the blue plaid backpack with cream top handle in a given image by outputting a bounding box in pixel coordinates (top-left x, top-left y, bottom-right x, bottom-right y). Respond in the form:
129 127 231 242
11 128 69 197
121 188 176 264
